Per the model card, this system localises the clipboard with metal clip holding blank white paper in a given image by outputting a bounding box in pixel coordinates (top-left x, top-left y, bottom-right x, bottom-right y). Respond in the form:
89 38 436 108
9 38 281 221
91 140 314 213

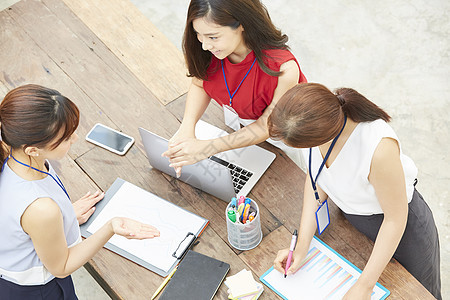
80 178 209 277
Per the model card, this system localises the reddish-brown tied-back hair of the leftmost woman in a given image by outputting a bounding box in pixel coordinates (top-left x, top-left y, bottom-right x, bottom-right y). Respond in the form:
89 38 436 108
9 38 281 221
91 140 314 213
0 84 80 169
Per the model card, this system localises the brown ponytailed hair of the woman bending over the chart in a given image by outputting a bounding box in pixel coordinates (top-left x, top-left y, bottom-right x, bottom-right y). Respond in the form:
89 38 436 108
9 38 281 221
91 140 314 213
267 83 391 148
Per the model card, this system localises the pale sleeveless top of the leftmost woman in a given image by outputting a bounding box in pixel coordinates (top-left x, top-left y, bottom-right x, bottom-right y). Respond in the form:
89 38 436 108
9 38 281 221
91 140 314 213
0 164 81 285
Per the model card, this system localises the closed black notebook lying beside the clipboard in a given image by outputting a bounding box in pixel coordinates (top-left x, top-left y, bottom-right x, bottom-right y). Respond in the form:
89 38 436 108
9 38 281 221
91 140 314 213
159 250 230 300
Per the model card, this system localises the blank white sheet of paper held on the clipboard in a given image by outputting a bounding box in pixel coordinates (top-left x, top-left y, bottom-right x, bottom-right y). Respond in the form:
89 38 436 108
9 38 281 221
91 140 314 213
87 182 205 272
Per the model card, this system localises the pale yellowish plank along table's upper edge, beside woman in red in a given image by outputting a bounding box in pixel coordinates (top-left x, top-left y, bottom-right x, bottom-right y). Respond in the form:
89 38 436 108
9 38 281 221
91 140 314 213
60 0 190 104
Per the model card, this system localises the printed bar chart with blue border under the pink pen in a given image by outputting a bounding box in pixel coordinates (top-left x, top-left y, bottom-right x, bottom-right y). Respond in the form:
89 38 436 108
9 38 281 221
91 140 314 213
260 237 390 300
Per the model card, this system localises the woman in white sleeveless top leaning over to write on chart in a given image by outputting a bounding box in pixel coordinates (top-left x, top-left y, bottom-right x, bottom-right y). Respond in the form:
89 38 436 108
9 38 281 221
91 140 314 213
268 83 441 300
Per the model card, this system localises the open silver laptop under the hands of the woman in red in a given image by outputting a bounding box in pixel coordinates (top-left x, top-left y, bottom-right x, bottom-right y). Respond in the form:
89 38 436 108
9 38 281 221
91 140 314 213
139 120 276 201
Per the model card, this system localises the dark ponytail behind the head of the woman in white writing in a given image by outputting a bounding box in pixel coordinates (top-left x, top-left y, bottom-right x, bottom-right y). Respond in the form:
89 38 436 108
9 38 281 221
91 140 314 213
335 88 391 123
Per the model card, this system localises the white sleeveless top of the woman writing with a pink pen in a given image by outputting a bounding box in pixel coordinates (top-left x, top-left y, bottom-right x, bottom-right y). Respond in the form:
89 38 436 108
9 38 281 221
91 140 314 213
302 119 417 215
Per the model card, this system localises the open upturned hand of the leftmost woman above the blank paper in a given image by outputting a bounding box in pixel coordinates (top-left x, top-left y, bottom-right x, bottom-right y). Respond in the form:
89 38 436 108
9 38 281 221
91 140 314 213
111 217 159 240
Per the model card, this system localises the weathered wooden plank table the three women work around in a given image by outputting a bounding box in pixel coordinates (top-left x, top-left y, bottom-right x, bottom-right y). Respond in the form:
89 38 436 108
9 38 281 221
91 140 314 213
0 0 433 299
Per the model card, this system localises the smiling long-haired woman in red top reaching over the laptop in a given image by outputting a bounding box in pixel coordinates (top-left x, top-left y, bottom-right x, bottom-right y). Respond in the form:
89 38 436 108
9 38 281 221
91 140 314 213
163 0 306 175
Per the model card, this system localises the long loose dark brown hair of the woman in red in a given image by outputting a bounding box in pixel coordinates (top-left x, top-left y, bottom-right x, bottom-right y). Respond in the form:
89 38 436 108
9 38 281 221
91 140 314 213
183 0 289 80
